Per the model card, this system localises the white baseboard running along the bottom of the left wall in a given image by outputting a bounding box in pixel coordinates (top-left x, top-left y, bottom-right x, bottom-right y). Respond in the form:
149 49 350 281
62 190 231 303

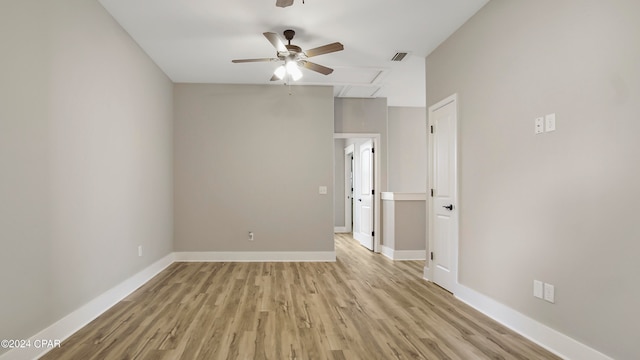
0 253 174 360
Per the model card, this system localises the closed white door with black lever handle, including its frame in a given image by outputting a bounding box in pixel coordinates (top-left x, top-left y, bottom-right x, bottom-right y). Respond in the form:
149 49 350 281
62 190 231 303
429 96 458 292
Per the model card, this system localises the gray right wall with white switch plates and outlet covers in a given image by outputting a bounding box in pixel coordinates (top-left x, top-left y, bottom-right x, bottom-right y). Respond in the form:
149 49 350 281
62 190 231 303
426 0 640 359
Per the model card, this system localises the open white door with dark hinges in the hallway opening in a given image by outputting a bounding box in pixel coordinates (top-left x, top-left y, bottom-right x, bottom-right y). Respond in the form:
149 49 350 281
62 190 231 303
353 140 374 250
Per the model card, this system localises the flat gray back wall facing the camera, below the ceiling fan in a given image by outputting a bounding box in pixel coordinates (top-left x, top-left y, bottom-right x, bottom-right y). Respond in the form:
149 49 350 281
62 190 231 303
174 84 334 251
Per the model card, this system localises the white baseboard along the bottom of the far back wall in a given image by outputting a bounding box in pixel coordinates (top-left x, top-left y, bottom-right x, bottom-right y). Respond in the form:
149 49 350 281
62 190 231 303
174 251 336 262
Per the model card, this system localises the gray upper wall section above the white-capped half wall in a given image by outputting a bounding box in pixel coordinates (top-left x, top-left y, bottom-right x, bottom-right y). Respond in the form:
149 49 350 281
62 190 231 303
387 106 427 193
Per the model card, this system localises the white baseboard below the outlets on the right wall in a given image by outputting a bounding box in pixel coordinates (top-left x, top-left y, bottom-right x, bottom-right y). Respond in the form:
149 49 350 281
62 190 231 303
455 284 613 360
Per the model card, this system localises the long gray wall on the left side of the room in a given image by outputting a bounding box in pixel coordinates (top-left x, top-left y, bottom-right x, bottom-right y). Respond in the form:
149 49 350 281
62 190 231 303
0 0 172 352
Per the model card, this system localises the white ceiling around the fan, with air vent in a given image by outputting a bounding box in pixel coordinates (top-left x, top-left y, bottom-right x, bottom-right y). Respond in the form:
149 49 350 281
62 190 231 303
99 0 488 106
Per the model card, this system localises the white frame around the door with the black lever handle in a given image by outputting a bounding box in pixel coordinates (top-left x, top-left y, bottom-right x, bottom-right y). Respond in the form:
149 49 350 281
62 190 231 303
424 93 460 294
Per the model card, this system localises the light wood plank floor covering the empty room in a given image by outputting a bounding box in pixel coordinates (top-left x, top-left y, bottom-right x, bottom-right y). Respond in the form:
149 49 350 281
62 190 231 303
42 235 559 360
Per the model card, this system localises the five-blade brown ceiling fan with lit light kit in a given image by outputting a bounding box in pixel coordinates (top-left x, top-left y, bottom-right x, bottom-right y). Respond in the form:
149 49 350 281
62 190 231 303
231 29 344 81
